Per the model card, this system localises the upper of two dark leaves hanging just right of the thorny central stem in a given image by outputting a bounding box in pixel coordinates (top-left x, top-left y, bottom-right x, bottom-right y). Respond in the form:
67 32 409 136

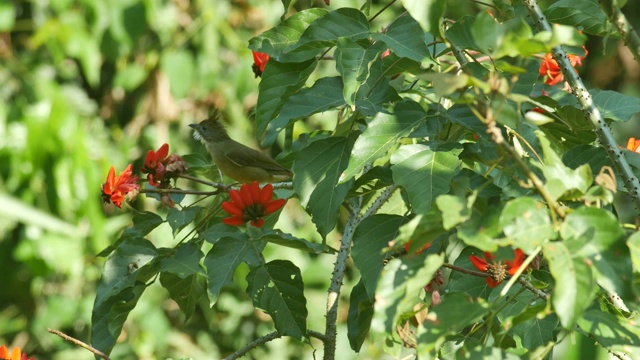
351 214 404 299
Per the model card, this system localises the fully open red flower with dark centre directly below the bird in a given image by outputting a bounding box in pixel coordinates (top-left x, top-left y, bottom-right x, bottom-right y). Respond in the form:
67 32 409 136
222 181 286 227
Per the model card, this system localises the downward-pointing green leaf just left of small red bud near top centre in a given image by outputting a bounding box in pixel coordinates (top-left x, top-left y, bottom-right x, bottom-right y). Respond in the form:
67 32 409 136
333 38 384 107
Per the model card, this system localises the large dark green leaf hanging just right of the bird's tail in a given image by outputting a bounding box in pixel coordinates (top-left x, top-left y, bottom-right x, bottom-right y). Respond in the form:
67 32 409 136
292 137 353 239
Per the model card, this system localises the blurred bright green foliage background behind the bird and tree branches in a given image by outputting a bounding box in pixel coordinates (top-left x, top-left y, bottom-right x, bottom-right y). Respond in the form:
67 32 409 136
0 0 640 359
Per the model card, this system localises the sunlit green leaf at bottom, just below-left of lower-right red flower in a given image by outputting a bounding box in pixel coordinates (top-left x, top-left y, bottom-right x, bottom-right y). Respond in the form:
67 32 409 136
416 293 489 358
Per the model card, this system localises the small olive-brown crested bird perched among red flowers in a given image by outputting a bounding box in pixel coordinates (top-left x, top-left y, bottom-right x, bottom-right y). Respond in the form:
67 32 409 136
189 112 293 184
